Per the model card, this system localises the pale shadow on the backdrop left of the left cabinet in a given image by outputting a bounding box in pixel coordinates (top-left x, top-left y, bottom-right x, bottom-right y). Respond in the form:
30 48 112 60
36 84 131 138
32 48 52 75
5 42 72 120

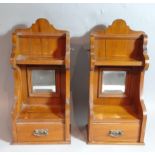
0 25 26 142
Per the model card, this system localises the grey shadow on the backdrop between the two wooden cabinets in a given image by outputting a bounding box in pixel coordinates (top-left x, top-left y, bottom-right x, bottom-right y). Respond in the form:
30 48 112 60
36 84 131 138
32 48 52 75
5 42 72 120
71 25 106 141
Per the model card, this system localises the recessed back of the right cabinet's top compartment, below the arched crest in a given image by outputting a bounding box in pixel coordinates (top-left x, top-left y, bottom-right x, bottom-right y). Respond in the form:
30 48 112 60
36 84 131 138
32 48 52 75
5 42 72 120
94 38 143 59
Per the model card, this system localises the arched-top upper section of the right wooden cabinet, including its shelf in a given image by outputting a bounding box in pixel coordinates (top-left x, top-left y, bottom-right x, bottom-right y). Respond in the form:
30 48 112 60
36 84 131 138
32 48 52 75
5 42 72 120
90 19 149 69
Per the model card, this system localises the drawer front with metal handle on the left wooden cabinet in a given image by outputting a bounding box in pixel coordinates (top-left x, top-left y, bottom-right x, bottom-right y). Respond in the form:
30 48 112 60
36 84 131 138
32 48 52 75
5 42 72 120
17 123 64 142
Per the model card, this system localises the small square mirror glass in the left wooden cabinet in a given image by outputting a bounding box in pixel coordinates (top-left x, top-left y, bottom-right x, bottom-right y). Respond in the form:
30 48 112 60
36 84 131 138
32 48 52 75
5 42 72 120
32 69 56 93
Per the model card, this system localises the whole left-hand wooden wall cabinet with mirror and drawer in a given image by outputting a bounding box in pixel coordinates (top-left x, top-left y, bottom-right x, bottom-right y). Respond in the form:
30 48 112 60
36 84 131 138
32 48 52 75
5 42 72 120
11 19 70 144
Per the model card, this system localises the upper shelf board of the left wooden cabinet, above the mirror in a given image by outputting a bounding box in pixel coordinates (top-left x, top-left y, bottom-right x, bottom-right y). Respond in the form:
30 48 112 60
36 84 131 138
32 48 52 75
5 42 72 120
12 55 65 65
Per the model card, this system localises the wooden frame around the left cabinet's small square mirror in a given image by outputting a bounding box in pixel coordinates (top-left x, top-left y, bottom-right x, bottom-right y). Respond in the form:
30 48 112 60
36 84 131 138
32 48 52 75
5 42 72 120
27 66 61 97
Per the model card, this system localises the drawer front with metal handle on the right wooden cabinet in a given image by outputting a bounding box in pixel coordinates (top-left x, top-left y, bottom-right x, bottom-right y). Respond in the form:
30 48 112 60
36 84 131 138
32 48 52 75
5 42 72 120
92 123 140 143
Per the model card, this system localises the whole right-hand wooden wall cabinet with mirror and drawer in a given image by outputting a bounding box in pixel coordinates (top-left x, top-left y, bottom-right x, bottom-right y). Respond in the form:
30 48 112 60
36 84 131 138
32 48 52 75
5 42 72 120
88 19 149 144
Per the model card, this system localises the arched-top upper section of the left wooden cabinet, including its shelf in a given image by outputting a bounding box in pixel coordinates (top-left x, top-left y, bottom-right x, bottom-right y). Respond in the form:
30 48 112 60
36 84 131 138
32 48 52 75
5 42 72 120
11 18 70 65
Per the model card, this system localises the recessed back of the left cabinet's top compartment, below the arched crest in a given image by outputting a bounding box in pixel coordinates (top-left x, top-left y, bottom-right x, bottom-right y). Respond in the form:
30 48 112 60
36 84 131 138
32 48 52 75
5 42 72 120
17 36 66 58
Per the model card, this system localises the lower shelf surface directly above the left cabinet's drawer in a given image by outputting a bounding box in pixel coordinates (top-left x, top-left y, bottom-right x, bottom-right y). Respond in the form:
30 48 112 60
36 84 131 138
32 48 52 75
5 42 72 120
18 104 64 122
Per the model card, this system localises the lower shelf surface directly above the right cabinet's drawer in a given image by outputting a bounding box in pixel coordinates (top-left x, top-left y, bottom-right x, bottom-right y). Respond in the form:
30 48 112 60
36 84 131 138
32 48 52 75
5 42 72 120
93 104 139 122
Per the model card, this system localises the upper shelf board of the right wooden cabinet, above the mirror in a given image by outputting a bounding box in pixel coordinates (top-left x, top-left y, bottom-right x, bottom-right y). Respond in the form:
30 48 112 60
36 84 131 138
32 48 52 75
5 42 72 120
95 58 143 66
